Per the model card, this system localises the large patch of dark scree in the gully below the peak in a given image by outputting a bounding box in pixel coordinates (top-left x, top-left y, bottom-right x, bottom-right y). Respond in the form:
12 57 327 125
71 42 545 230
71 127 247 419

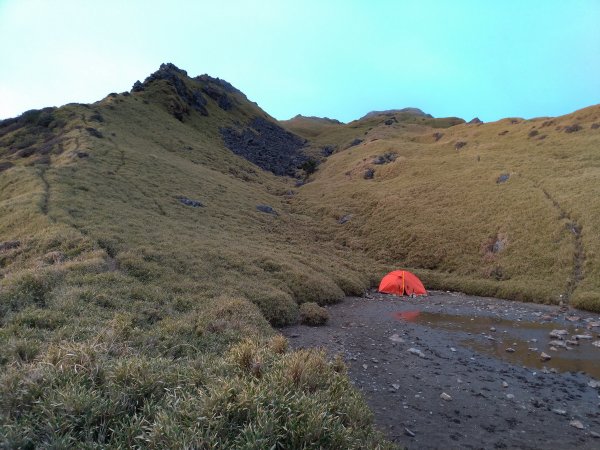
220 117 308 176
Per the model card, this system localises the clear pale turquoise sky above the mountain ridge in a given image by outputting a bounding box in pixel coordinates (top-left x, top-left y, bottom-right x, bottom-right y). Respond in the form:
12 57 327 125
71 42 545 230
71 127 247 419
0 0 600 121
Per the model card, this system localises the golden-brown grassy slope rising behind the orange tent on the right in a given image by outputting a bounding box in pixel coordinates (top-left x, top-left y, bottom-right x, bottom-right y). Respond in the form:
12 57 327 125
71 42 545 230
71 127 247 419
287 106 600 311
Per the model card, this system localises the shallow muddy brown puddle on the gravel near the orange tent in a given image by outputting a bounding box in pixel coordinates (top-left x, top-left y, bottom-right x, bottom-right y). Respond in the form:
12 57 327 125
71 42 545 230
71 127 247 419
394 311 600 379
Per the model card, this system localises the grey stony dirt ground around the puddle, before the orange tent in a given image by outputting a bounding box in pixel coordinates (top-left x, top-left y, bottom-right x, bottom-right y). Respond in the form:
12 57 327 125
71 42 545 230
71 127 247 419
282 292 600 449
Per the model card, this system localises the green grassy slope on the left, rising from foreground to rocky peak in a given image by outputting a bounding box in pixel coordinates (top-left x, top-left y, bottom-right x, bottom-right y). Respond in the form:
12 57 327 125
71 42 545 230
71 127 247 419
0 73 386 448
